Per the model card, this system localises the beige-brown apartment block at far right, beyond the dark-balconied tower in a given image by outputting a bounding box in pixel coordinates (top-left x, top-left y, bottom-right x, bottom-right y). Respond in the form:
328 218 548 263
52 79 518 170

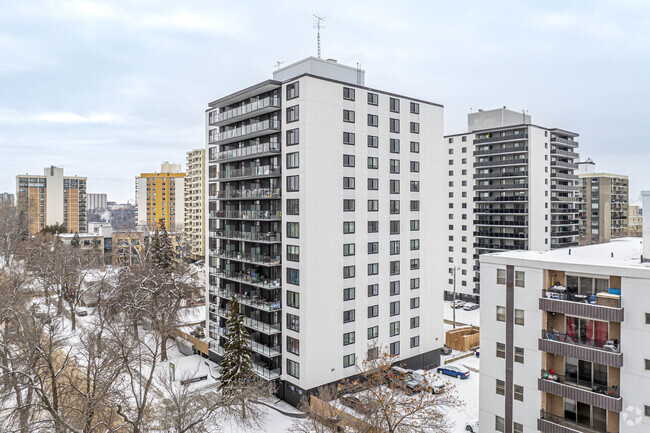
579 173 629 245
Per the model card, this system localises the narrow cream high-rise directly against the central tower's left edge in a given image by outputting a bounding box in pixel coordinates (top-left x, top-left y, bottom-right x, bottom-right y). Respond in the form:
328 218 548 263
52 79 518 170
185 149 206 260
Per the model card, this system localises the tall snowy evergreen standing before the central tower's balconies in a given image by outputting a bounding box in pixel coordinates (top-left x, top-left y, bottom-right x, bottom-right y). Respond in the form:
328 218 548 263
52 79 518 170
219 296 255 394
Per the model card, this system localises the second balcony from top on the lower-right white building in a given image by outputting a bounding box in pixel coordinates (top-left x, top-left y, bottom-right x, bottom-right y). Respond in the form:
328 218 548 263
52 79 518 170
537 330 623 367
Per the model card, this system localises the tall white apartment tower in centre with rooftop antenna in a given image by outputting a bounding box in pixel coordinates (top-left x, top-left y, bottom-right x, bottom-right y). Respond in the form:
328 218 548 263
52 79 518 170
206 58 446 404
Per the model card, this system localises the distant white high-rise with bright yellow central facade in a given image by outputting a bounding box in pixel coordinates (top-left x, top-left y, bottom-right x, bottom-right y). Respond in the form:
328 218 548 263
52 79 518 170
135 162 185 231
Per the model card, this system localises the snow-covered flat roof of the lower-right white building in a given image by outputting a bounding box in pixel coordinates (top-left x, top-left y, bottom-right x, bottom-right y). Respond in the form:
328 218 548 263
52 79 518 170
481 238 650 272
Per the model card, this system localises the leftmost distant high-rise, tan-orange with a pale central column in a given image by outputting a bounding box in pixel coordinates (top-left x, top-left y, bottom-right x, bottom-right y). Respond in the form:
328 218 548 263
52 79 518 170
16 166 86 234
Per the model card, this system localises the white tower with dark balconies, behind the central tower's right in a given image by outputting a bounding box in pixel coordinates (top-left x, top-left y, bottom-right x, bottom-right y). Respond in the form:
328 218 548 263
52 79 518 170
438 107 579 300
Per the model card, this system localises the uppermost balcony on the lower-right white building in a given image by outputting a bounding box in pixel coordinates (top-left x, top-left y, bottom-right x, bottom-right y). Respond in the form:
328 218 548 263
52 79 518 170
539 286 624 323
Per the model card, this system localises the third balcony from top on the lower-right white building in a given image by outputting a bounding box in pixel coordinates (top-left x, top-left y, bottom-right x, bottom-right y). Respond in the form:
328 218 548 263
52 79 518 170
537 370 623 412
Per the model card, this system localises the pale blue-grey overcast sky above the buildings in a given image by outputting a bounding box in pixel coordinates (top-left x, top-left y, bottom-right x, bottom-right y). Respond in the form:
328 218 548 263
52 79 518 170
0 0 650 203
